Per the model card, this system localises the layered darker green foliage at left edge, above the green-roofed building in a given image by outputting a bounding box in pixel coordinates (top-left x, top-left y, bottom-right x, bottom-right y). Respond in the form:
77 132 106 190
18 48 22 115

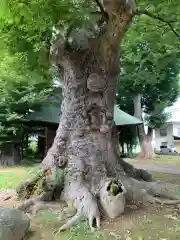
0 45 51 148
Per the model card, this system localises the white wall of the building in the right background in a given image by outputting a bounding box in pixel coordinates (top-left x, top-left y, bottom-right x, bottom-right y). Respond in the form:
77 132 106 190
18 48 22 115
155 123 174 151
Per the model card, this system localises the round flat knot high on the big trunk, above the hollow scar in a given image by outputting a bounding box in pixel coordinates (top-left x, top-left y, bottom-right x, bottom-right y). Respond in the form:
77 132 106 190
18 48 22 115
87 73 107 92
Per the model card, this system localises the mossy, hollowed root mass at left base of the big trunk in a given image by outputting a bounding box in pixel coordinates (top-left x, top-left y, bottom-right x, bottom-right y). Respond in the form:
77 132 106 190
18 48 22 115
16 167 64 213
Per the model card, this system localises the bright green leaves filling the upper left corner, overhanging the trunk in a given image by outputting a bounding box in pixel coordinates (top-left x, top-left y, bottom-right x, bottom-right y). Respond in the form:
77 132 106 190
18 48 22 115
0 0 99 74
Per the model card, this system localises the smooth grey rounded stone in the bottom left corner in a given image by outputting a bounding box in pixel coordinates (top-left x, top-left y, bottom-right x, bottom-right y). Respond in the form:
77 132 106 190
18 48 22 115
0 208 30 240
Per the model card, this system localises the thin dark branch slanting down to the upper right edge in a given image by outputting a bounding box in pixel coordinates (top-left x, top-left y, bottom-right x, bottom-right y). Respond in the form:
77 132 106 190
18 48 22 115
134 10 180 38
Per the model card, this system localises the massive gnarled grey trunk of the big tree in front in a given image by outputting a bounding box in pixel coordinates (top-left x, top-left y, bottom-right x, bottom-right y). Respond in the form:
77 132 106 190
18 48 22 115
16 0 180 230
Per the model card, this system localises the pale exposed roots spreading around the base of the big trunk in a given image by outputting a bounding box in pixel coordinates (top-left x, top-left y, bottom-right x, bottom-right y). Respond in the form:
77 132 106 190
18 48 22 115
14 163 180 233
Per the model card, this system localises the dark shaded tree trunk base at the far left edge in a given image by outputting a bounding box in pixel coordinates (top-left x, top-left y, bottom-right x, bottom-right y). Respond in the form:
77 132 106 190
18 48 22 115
0 142 21 166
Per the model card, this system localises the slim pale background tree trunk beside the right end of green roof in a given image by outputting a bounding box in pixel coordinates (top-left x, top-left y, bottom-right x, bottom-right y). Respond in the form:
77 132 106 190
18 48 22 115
133 94 153 159
